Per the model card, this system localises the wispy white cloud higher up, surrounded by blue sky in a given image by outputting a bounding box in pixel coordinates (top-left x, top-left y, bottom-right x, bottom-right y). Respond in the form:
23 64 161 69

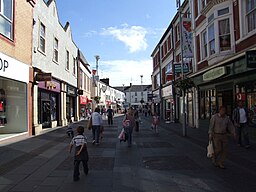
101 24 148 53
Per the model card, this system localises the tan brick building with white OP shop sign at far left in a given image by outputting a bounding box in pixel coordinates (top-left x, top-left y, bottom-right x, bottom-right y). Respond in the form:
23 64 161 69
0 0 35 135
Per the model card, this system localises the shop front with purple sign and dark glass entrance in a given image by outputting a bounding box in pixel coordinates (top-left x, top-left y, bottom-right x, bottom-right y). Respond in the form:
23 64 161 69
38 79 61 128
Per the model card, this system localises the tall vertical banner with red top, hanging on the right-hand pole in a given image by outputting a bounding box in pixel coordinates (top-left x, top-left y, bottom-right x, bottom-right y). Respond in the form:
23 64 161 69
182 18 194 58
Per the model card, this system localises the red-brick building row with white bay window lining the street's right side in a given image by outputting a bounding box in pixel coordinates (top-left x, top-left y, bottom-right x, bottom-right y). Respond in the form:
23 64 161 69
152 0 256 140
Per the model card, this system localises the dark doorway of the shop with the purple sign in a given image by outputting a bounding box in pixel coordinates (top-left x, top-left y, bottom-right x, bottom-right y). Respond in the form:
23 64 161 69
42 100 51 128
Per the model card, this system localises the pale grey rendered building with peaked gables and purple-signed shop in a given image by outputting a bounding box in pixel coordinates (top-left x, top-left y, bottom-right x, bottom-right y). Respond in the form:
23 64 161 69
32 0 79 133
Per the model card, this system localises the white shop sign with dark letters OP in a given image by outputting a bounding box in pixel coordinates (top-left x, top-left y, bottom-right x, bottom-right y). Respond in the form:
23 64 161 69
0 52 29 83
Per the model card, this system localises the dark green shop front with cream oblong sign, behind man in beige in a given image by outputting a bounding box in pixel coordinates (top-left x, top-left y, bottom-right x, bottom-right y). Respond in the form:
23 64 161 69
192 56 256 132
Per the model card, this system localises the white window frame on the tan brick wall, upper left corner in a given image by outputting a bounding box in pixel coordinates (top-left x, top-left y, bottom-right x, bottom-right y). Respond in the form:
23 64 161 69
0 0 15 41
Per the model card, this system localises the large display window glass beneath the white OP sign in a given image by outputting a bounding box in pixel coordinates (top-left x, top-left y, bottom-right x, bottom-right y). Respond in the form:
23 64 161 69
0 77 28 133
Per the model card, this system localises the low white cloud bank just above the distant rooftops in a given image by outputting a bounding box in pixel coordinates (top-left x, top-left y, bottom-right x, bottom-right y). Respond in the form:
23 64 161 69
95 59 153 86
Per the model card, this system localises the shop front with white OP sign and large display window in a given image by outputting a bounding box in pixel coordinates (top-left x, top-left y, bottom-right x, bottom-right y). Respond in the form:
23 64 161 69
0 53 29 134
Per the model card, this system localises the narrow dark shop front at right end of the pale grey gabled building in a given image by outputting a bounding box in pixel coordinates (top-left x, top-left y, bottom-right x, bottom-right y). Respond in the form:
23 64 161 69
66 85 77 121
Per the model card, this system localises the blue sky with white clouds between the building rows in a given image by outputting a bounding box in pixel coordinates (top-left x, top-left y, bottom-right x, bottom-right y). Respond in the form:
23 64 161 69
56 0 177 86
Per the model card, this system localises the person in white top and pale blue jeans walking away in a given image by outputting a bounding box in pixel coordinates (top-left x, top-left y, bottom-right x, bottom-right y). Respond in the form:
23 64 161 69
91 107 103 145
